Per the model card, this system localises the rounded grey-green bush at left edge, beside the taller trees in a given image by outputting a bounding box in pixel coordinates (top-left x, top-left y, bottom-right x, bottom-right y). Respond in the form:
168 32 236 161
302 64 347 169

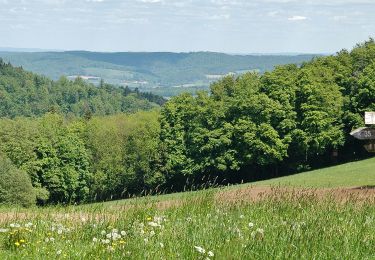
0 154 36 207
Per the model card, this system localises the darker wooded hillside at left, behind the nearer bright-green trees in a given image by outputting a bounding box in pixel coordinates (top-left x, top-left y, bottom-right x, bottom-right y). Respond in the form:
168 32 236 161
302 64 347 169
0 59 163 117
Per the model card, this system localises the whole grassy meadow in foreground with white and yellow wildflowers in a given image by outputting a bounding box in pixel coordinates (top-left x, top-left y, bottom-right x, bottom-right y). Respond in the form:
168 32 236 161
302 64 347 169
0 159 375 259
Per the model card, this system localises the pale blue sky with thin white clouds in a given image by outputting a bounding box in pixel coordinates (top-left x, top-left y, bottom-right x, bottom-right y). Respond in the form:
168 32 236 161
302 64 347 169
0 0 375 53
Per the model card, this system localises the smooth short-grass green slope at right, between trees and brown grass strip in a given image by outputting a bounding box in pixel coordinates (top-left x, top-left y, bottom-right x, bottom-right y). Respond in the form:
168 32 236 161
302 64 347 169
251 158 375 188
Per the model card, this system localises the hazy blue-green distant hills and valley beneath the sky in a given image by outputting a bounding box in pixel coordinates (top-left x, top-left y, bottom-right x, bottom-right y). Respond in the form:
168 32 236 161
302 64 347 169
0 51 317 96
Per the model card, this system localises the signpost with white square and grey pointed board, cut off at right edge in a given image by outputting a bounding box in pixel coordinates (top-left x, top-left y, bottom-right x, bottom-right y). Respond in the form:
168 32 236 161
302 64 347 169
350 112 375 153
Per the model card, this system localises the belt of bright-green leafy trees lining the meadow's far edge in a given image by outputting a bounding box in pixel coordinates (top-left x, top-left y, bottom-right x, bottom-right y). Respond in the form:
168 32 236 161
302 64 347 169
0 39 375 204
